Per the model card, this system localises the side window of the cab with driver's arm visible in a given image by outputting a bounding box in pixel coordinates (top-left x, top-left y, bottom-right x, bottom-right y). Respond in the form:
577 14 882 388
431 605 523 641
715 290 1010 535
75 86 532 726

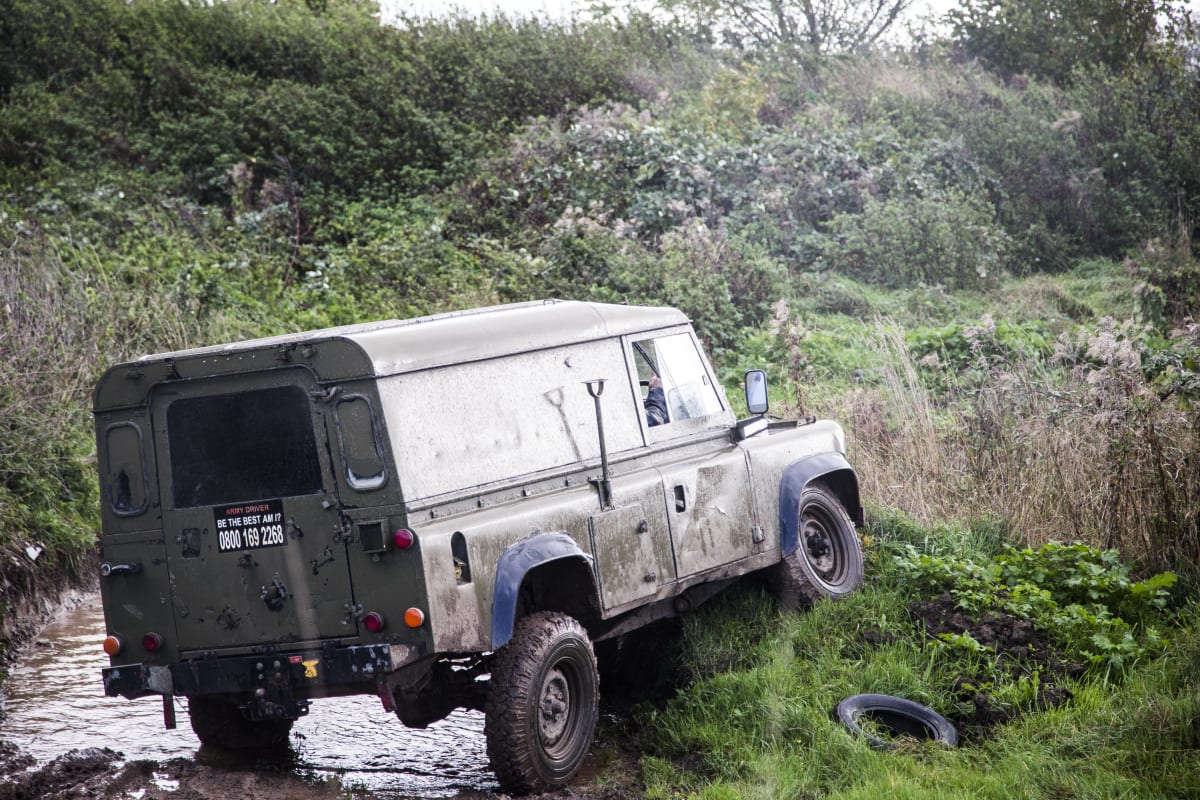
634 333 722 427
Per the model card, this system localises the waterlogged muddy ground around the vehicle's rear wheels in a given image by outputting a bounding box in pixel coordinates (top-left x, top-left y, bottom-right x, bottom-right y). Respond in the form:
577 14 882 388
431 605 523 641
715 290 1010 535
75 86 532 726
0 596 636 800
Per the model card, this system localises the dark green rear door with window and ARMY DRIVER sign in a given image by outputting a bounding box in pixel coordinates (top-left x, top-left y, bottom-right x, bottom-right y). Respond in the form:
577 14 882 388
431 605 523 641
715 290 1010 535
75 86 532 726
151 368 358 652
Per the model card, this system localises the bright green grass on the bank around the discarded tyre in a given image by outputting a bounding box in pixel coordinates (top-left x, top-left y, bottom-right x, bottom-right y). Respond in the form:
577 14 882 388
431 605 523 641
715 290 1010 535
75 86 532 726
635 515 1200 800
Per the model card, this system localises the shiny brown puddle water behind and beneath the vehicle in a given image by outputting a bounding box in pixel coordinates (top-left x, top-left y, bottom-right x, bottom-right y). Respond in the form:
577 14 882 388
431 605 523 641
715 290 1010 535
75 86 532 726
0 596 497 798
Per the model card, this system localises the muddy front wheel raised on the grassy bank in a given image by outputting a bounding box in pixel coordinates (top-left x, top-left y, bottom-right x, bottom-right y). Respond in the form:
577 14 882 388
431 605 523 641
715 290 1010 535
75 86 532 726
767 486 863 610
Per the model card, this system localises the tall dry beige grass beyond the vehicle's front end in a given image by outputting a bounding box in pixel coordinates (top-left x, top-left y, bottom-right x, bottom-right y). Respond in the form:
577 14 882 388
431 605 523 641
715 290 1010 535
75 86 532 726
836 323 1200 575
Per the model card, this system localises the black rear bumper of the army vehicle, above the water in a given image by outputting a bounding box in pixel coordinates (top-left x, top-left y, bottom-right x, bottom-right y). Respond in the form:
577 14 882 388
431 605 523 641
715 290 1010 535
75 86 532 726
102 644 392 698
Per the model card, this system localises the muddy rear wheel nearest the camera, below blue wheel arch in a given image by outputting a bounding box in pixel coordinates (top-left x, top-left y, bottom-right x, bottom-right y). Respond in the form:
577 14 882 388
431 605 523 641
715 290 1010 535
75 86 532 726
484 612 600 794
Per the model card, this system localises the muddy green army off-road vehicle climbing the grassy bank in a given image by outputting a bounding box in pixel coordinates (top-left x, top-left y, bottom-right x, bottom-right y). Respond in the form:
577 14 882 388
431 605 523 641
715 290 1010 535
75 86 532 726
95 301 863 793
